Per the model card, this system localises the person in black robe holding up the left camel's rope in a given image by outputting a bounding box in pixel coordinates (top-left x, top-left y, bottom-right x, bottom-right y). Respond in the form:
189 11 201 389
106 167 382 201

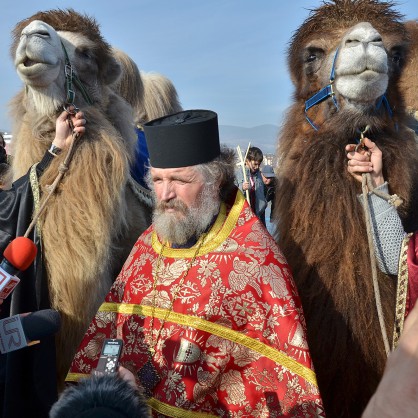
0 108 86 418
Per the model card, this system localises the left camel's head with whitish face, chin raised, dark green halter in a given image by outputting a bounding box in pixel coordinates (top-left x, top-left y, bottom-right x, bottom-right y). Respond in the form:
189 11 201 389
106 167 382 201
11 9 120 116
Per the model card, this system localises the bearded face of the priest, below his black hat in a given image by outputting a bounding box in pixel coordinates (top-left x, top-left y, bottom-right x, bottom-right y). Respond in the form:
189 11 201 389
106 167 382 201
150 166 219 244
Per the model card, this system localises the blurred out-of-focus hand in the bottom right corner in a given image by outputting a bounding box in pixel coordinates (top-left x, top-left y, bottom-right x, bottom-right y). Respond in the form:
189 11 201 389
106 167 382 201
362 303 418 418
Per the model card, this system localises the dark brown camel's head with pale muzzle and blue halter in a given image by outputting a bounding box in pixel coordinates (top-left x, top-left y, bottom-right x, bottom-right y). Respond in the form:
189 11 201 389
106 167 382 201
288 0 408 129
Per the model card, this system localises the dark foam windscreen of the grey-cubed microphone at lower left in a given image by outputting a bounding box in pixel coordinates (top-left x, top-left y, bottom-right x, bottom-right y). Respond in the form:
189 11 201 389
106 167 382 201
20 309 61 341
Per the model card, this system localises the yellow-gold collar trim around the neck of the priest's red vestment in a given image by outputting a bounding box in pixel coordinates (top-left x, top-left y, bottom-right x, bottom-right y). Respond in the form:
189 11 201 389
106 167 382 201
152 192 245 258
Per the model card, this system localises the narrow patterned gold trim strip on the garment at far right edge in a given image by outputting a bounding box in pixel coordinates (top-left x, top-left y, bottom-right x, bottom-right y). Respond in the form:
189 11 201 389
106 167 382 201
392 234 412 350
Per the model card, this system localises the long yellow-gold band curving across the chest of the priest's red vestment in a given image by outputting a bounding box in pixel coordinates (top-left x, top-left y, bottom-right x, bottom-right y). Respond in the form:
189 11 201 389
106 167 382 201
98 303 317 386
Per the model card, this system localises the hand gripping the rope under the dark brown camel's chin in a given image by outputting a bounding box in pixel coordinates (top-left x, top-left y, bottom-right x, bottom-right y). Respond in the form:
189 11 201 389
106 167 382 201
345 138 385 187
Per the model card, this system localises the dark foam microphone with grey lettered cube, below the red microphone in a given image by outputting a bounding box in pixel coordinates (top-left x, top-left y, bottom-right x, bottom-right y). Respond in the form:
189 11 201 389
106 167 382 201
0 309 61 354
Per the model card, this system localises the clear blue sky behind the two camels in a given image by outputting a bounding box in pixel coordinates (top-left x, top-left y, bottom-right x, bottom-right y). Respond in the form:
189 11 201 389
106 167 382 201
0 0 418 130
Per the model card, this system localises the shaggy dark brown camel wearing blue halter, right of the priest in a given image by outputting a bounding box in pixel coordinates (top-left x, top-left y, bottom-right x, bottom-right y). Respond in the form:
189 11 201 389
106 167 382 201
275 0 418 418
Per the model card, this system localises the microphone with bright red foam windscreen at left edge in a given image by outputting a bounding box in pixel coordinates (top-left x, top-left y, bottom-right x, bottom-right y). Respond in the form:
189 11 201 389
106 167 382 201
0 237 38 299
